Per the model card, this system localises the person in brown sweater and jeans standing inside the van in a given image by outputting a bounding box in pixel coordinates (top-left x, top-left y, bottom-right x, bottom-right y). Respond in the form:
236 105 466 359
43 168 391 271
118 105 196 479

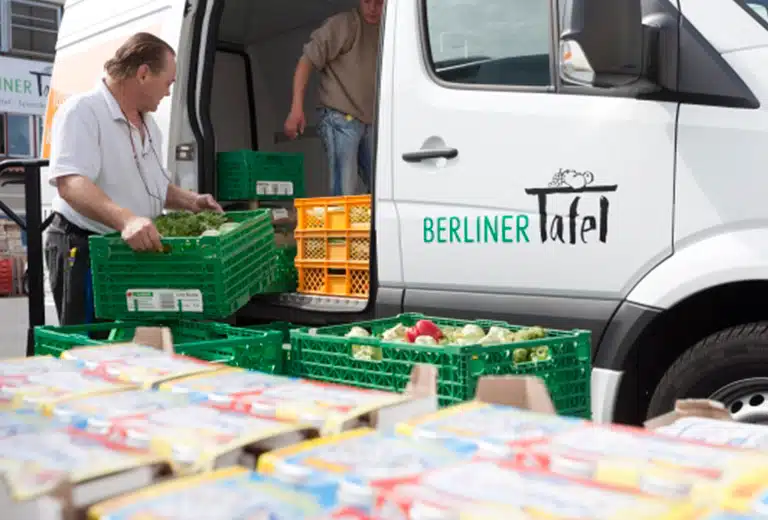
285 0 384 196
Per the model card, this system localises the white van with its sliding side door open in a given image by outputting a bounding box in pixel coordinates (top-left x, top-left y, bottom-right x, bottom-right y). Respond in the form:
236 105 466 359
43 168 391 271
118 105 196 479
46 0 768 422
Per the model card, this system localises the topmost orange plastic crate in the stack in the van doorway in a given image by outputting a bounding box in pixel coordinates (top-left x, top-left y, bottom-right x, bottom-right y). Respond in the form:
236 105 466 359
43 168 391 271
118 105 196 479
293 195 371 231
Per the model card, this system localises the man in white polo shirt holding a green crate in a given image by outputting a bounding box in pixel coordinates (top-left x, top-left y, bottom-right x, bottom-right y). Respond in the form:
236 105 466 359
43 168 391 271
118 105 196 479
45 33 221 325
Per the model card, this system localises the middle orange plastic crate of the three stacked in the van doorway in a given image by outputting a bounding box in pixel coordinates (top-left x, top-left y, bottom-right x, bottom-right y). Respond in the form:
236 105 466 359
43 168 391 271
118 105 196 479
295 231 371 265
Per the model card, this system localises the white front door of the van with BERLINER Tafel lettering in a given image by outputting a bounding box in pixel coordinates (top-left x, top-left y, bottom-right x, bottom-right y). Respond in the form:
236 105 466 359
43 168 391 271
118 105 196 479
392 1 677 301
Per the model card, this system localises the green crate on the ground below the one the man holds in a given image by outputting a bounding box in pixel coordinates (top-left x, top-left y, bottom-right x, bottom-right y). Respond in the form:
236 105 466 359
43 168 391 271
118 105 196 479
35 320 285 374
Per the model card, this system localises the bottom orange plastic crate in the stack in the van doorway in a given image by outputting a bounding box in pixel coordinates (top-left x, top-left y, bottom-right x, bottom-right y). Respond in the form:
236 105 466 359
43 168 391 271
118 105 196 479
296 260 371 298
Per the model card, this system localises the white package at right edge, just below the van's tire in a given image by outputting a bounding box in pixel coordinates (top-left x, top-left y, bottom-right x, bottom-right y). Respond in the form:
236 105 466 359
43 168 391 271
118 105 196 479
655 417 768 451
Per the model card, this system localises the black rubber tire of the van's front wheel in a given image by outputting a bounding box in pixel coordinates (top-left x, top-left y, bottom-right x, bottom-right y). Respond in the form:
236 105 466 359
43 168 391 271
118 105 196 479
647 322 768 417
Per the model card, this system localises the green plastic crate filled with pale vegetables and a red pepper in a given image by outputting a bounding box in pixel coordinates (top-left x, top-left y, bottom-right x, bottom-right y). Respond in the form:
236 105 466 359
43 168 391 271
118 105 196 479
290 314 591 419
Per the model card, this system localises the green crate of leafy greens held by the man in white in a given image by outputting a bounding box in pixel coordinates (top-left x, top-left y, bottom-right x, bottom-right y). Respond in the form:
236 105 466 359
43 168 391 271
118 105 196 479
90 209 275 320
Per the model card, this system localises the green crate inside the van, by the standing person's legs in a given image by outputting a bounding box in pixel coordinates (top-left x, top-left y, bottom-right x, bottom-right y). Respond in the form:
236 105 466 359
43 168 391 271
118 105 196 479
217 150 305 201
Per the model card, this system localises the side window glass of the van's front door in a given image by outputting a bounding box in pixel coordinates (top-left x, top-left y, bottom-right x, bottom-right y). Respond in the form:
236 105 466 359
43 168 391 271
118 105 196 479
424 0 552 86
